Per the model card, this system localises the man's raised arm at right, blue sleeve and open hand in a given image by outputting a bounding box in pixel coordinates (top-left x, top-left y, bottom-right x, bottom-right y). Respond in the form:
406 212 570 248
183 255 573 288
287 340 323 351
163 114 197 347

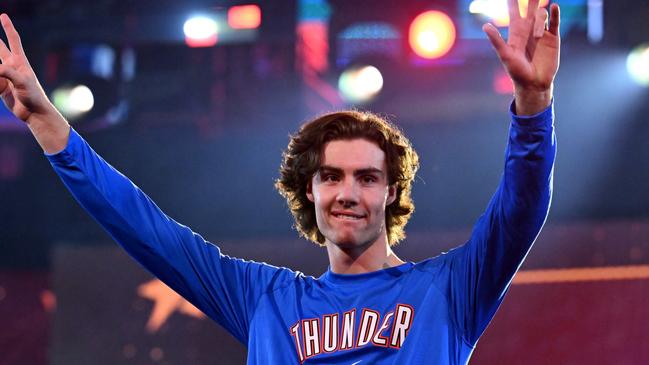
446 0 560 346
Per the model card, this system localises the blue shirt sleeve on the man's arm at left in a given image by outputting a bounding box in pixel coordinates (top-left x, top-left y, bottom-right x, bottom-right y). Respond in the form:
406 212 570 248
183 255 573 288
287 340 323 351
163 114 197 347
46 129 296 344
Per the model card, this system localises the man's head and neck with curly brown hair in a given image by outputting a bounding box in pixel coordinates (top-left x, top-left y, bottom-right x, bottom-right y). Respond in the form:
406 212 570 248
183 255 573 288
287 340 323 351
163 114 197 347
276 111 419 274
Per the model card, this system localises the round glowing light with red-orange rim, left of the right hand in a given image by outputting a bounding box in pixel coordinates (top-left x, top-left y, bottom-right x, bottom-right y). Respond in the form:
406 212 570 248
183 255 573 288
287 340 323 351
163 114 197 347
408 10 455 59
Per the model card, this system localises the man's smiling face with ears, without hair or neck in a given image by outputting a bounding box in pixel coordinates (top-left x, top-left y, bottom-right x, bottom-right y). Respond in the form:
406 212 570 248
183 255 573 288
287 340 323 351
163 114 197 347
307 139 396 248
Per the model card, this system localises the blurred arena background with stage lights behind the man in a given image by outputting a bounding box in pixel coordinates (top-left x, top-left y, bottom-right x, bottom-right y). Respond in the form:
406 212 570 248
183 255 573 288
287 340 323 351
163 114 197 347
0 0 649 365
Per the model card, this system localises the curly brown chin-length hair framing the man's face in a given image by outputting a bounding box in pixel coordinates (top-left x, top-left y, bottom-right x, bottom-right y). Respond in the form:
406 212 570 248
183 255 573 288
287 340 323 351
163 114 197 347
275 110 419 246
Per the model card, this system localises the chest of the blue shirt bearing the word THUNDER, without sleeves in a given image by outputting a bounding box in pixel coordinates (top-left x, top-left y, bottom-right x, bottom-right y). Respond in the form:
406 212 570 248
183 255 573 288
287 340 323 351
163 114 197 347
246 282 450 363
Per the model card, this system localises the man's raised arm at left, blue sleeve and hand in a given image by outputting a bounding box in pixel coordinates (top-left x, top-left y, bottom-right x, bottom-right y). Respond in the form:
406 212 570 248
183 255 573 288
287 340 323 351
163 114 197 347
0 14 294 344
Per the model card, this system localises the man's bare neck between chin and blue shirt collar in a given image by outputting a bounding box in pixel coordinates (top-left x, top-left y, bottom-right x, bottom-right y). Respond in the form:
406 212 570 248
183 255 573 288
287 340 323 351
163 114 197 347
325 236 404 274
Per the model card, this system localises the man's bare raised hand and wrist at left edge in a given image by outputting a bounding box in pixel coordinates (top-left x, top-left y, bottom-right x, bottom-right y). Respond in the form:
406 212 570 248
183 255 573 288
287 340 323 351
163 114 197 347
0 14 70 153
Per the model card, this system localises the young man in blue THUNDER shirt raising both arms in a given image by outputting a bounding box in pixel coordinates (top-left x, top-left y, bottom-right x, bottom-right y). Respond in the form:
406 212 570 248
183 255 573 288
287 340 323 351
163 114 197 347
0 0 559 364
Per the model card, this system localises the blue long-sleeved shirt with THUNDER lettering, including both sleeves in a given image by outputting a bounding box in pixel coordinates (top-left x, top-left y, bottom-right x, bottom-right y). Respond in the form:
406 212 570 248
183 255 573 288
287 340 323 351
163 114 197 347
46 101 556 365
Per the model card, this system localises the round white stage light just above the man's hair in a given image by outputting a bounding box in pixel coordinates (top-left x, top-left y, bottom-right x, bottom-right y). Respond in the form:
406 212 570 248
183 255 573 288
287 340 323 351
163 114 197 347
338 66 383 104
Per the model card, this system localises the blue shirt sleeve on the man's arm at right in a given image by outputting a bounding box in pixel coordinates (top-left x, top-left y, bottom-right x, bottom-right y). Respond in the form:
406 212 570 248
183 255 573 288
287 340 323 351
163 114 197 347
445 104 556 346
